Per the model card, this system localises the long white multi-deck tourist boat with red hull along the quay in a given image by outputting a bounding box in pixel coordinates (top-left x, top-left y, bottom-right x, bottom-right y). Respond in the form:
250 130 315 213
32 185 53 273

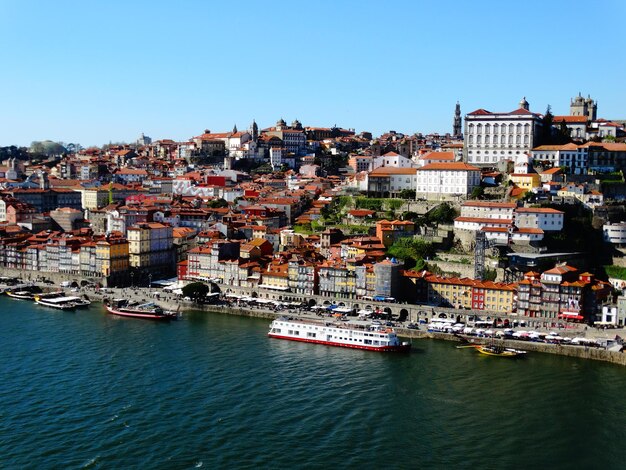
267 317 411 352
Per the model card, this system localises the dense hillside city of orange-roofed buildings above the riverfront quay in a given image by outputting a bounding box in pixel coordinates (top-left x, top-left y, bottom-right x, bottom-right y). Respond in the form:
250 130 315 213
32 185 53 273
0 96 626 321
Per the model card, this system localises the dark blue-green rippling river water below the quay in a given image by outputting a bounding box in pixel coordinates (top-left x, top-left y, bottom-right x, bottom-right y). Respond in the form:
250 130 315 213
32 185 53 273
0 297 626 469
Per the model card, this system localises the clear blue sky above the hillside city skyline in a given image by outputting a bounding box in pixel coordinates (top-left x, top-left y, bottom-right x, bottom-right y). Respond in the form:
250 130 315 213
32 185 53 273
0 0 626 146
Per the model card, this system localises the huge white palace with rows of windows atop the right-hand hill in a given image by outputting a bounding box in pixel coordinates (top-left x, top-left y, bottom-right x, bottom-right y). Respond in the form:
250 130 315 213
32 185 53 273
463 98 542 166
